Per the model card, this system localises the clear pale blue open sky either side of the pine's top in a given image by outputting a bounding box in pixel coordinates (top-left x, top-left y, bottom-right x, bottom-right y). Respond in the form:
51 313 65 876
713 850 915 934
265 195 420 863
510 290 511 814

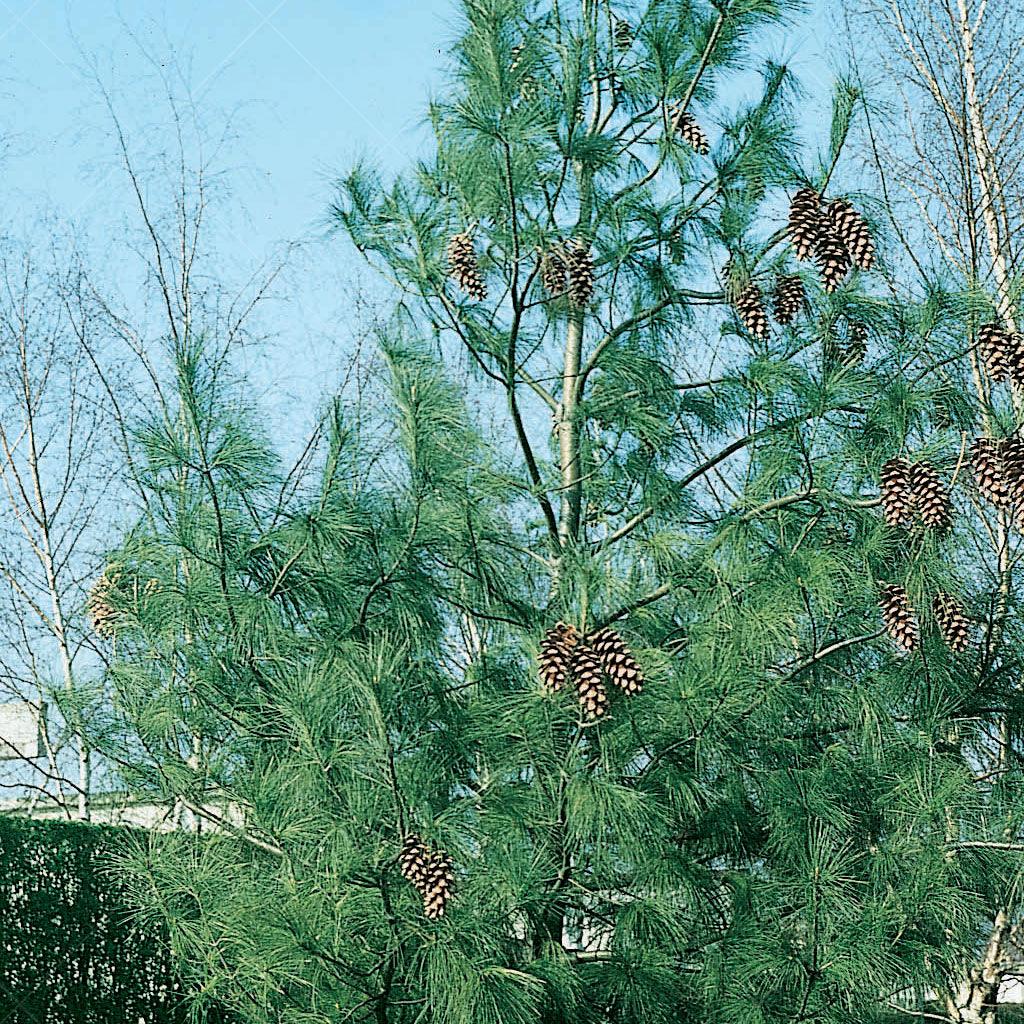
0 0 828 444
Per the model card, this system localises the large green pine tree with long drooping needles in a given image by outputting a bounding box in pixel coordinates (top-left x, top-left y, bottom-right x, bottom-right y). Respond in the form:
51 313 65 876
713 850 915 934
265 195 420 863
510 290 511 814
81 0 1022 1024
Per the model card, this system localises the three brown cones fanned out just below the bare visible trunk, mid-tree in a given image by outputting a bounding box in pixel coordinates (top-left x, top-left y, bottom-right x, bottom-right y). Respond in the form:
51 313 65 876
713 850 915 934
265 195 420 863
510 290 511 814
539 623 643 721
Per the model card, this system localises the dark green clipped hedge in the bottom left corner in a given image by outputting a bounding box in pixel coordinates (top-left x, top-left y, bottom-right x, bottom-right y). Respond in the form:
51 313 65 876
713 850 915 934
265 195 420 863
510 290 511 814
0 816 207 1024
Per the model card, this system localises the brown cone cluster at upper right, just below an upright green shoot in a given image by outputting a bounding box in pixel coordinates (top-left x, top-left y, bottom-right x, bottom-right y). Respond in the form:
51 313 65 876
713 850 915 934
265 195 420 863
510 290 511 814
790 186 874 294
